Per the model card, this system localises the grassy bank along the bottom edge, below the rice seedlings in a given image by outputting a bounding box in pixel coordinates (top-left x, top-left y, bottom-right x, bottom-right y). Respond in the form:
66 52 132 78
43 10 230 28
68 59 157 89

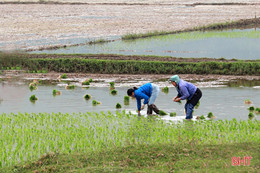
2 143 260 173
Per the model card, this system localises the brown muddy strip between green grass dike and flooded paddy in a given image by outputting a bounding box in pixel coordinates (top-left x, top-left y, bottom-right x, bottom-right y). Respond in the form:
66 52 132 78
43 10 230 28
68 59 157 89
0 70 260 83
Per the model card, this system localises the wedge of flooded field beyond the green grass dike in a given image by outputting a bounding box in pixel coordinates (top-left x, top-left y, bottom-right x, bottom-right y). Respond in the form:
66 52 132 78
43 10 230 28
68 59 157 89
31 28 260 60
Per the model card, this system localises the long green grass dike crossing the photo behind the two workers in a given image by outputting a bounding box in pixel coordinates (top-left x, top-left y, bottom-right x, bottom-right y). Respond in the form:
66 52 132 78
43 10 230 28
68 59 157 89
0 54 260 75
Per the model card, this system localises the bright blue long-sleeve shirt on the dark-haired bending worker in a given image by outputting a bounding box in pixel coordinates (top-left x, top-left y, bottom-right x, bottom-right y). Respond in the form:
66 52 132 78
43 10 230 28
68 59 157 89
134 83 152 111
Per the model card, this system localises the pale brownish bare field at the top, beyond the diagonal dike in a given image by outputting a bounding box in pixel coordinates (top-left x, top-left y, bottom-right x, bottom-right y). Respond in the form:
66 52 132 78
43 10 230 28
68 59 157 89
0 0 260 50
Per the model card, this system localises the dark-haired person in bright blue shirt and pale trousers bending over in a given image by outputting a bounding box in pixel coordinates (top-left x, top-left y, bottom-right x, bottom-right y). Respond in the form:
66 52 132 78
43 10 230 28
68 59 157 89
127 83 160 115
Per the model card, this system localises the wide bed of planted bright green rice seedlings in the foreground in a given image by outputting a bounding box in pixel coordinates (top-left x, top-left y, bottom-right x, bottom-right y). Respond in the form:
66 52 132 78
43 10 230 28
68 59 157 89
0 111 260 168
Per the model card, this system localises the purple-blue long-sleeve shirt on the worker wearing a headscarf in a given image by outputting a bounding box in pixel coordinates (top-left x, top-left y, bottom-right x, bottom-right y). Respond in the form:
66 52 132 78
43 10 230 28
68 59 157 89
176 80 197 100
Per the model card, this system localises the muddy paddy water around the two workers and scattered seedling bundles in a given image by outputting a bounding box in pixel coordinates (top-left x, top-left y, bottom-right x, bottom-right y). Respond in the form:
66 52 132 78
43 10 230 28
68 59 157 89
0 82 260 120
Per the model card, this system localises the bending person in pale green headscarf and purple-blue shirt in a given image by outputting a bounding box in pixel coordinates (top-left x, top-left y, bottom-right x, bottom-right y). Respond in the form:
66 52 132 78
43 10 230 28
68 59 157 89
170 75 202 120
